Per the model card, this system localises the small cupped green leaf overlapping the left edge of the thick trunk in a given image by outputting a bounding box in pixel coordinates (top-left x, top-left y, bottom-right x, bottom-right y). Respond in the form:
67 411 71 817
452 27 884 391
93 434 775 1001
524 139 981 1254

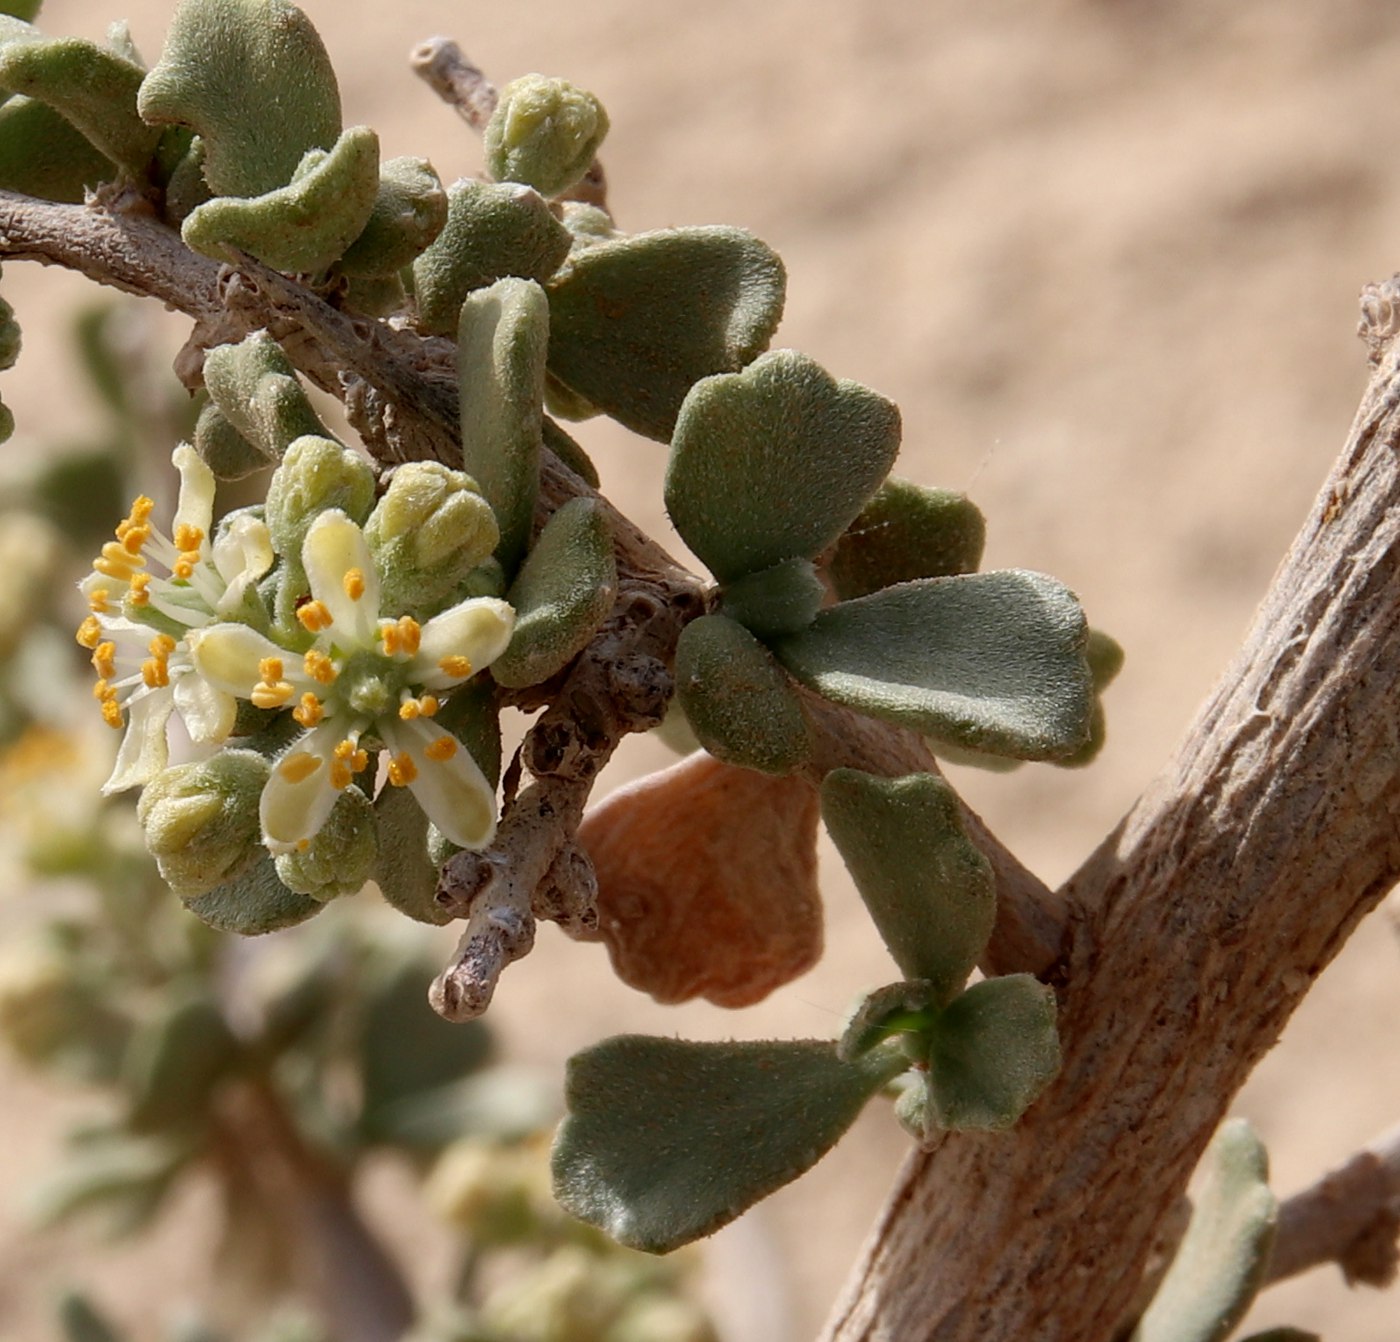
927 974 1060 1131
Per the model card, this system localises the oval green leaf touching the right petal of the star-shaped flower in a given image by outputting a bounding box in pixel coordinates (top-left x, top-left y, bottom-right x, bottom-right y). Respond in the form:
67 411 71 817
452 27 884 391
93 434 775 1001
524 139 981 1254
491 498 617 688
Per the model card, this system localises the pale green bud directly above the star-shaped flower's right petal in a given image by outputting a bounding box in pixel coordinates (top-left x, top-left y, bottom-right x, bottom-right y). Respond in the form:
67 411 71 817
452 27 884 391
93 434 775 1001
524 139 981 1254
364 462 500 610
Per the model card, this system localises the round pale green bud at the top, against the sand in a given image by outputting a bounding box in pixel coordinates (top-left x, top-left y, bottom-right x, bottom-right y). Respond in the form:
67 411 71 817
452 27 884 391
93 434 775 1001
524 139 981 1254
484 74 608 196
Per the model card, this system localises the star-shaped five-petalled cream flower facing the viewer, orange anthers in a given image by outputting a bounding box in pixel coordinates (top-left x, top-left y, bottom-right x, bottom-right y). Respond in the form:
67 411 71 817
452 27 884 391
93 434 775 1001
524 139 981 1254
189 509 515 852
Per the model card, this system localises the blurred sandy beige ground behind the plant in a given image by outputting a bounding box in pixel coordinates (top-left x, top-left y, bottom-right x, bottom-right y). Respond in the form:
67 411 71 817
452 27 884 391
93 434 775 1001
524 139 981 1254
0 0 1400 1342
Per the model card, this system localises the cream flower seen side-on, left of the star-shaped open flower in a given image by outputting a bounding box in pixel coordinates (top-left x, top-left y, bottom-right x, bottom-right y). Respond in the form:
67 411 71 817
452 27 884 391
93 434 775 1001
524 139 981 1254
77 444 273 792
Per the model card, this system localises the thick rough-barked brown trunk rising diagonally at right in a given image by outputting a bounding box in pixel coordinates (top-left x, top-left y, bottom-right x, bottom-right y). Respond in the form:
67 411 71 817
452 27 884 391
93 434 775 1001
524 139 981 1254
827 320 1400 1342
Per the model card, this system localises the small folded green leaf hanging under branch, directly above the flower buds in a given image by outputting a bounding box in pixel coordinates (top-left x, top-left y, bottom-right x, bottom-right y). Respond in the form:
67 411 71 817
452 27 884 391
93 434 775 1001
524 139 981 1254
204 330 330 462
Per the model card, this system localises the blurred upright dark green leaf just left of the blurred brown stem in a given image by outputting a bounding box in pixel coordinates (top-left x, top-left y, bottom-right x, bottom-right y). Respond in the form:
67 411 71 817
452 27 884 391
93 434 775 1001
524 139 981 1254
122 989 241 1133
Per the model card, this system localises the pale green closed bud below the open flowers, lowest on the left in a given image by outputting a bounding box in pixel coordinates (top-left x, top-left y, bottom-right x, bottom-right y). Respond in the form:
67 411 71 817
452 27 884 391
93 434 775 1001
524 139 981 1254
136 750 269 900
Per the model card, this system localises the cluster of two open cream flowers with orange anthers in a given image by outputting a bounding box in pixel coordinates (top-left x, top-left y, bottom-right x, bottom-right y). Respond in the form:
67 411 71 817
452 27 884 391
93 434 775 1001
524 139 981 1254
77 439 514 890
